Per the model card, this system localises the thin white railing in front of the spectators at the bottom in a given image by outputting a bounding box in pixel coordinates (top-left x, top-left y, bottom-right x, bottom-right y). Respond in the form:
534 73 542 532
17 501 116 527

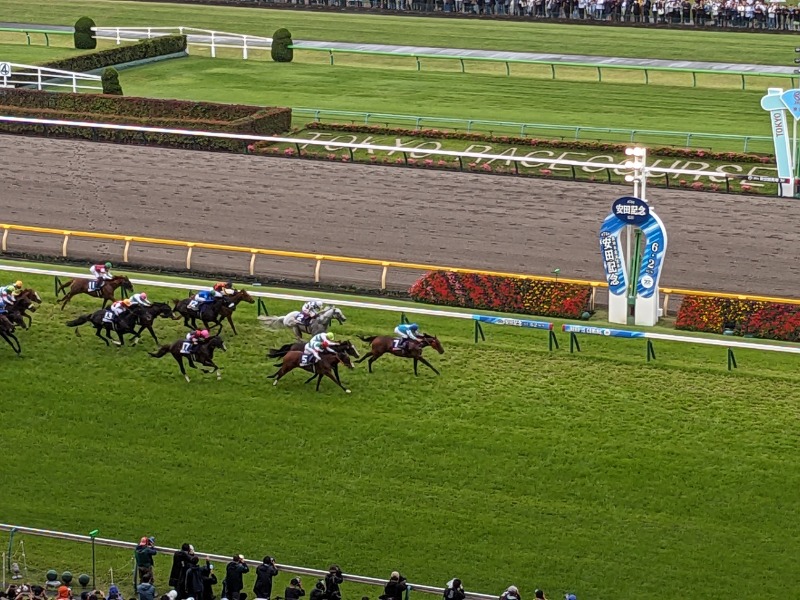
0 523 497 600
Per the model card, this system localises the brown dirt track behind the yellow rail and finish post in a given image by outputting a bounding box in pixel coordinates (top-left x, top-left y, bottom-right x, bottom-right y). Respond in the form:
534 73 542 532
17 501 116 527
0 136 800 297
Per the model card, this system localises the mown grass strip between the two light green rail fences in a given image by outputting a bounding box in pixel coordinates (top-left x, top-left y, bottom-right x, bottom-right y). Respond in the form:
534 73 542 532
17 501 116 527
115 57 769 138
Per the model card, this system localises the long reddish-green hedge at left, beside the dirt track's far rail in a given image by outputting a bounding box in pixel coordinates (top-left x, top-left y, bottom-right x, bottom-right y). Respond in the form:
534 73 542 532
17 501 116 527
0 89 292 152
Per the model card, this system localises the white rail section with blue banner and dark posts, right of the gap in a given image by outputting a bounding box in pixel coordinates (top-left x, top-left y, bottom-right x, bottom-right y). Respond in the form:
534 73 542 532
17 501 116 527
561 323 800 371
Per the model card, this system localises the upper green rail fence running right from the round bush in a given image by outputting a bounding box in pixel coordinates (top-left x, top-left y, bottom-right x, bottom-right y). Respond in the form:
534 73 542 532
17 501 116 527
291 42 796 90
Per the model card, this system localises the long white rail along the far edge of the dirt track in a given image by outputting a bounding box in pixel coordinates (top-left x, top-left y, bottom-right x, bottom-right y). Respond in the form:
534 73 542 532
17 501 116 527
0 115 780 183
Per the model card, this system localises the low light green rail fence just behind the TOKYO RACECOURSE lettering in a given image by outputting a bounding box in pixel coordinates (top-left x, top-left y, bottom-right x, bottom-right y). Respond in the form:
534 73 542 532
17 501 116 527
292 107 774 154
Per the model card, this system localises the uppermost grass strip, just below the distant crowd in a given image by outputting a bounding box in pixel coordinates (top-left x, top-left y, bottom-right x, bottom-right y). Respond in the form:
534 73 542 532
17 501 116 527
0 0 793 65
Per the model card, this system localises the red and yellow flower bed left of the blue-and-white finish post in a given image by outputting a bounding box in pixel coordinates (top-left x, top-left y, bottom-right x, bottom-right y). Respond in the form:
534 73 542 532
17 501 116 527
409 271 592 319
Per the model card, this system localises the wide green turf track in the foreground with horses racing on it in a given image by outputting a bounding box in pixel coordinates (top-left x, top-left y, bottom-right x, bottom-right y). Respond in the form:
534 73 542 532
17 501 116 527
0 260 800 600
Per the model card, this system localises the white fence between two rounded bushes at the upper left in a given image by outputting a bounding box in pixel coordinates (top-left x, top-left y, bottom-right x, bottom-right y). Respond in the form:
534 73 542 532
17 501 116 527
92 26 272 60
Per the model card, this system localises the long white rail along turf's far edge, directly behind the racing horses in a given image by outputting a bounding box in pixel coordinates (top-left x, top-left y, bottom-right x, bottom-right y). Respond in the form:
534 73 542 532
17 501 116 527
6 263 800 354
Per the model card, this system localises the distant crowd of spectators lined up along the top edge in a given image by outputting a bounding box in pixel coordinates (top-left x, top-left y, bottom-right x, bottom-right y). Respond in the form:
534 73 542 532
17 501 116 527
260 0 800 31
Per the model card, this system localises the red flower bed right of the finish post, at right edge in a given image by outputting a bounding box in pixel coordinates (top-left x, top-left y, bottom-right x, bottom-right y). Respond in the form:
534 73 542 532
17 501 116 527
675 296 800 342
